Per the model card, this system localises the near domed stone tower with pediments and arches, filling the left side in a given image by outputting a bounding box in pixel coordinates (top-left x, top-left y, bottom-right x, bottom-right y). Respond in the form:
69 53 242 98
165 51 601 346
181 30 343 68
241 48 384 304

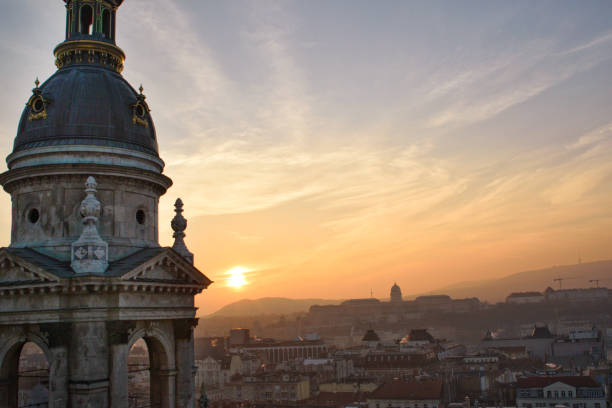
0 0 211 408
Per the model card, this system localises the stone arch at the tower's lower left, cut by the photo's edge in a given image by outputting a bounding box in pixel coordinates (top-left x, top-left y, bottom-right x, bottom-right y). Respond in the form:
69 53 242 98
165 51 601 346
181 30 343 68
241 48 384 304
0 333 54 408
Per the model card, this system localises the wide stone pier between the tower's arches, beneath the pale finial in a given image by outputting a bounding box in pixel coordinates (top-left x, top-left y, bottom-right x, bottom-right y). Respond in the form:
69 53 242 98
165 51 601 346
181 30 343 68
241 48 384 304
68 322 110 408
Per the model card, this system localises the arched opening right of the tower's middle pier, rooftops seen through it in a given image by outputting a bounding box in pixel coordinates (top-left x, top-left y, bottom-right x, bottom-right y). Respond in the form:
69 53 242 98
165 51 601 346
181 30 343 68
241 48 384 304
128 338 153 408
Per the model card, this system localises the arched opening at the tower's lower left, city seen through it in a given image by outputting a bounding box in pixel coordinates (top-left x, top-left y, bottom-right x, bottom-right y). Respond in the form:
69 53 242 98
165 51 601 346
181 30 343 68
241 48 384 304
17 342 49 408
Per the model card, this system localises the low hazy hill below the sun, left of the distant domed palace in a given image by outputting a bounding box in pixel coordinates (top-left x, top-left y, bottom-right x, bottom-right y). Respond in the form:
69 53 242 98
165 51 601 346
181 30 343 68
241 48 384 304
206 297 341 318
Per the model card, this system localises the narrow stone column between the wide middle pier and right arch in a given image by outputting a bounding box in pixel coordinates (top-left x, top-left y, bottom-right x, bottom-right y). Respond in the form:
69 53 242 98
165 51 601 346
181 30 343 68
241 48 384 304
106 320 136 408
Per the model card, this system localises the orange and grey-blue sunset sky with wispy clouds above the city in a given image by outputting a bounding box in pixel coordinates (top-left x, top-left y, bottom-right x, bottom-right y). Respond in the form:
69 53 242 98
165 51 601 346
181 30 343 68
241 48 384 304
0 0 612 314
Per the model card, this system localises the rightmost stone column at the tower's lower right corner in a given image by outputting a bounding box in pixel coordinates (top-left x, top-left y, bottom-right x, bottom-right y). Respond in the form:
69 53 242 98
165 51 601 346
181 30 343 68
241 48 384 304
174 319 198 408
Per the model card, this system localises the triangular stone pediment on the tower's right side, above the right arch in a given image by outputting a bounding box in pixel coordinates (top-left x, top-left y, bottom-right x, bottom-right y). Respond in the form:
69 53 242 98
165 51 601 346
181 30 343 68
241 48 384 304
123 248 211 287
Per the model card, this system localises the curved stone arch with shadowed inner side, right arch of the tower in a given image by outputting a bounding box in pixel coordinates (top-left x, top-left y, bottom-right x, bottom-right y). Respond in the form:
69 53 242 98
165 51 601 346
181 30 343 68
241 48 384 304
125 325 176 408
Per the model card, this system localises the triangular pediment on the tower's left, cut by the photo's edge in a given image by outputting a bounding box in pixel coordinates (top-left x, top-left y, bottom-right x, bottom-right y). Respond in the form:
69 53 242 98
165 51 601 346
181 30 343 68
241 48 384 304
0 249 59 286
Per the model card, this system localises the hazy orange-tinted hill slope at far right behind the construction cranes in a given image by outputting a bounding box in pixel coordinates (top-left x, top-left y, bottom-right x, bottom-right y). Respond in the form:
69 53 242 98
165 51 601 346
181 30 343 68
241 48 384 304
416 260 612 302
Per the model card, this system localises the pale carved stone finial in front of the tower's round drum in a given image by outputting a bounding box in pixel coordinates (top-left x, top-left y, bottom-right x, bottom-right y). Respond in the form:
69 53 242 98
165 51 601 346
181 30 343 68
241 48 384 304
70 176 108 274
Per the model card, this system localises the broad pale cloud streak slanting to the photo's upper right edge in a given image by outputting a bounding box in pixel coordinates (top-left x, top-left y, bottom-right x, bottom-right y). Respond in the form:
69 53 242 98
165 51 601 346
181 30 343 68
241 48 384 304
426 33 612 127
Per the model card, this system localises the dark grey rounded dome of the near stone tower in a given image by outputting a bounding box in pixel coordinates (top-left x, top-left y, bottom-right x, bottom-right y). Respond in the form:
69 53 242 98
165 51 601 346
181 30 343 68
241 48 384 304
13 65 159 157
